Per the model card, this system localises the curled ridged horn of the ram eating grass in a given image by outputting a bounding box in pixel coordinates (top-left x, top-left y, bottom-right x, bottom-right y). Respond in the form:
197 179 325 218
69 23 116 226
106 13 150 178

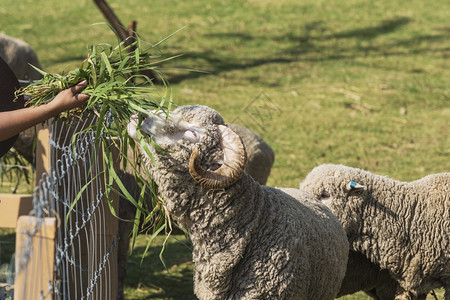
189 125 247 189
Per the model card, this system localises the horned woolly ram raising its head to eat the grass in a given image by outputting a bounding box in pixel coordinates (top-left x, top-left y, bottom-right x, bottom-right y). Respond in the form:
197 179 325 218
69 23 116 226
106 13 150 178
128 106 348 300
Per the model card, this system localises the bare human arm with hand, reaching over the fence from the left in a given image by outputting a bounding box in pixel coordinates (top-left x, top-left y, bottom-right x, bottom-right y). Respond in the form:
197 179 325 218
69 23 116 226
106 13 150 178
0 81 89 141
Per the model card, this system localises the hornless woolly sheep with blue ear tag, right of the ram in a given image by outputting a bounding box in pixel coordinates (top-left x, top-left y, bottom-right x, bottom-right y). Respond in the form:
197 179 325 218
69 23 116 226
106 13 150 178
300 164 450 300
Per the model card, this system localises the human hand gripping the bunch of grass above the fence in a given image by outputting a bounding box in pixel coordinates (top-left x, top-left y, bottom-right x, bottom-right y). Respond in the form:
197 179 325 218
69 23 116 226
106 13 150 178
48 80 89 116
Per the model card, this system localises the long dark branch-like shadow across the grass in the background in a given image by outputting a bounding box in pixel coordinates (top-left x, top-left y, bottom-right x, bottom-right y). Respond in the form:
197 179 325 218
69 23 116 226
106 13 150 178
164 17 450 83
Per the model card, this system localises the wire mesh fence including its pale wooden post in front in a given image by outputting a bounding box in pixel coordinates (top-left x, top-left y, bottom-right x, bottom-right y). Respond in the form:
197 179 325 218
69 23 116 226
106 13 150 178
14 115 118 299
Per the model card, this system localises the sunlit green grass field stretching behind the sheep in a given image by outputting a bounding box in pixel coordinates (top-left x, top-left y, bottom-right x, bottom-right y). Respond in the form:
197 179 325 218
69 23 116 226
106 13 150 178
0 0 450 299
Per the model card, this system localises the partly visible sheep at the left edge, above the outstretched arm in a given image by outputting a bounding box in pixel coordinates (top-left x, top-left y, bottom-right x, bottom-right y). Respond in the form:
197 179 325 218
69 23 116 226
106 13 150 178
0 33 42 80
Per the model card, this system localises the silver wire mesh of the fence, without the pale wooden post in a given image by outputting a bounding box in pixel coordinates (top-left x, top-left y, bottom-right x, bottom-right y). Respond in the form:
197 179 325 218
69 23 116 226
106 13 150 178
16 115 118 300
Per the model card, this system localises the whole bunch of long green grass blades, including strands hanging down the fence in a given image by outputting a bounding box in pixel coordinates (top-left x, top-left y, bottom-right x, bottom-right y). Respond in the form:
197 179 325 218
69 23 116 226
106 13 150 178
17 25 181 260
